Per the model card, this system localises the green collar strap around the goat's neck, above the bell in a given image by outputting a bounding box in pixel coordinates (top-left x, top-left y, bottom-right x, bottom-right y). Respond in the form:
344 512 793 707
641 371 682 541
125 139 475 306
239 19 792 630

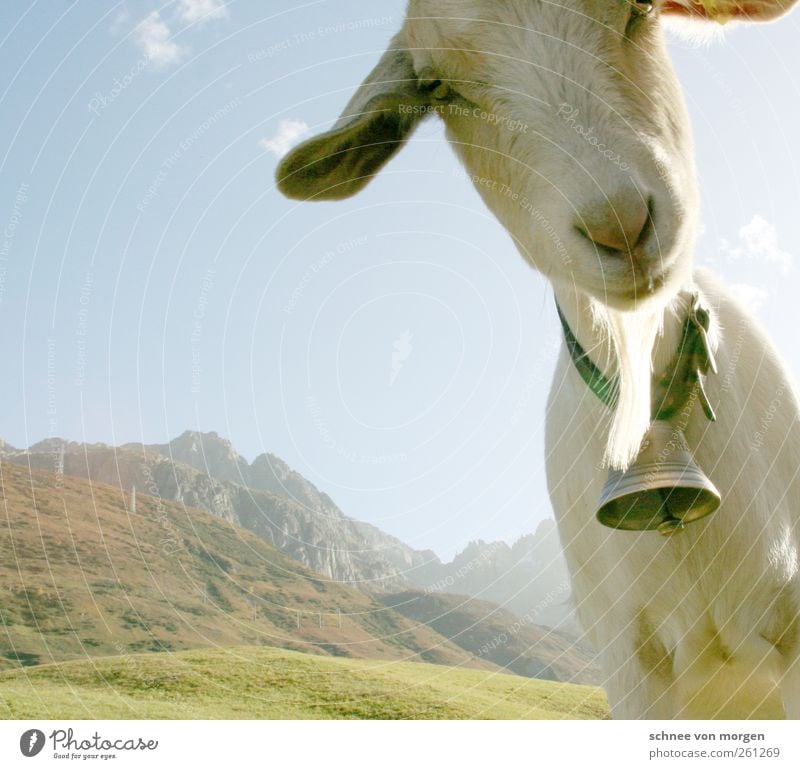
556 293 717 422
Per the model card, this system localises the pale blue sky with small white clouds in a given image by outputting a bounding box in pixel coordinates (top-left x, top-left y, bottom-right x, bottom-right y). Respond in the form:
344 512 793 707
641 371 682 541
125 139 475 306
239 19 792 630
0 0 800 558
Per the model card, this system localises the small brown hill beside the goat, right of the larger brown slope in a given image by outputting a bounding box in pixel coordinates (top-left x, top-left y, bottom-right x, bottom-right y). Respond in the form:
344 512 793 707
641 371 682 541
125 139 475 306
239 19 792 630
381 591 603 684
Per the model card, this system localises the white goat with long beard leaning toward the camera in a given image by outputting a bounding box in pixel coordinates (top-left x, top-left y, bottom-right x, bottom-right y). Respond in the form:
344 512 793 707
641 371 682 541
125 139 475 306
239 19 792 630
278 0 800 718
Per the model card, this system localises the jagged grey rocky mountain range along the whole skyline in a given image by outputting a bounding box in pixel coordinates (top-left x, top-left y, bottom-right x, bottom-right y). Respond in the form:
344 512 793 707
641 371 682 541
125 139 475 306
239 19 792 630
2 431 579 633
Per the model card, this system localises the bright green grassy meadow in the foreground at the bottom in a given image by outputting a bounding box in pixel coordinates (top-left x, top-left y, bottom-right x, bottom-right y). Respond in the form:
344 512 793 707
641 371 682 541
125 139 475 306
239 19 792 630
0 647 607 719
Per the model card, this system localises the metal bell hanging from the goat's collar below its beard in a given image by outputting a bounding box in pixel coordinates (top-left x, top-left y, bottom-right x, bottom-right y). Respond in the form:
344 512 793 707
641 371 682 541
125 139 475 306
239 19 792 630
597 419 721 536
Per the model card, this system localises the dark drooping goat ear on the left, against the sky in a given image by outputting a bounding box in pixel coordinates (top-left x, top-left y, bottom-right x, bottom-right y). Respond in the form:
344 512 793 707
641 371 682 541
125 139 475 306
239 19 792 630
276 32 428 200
